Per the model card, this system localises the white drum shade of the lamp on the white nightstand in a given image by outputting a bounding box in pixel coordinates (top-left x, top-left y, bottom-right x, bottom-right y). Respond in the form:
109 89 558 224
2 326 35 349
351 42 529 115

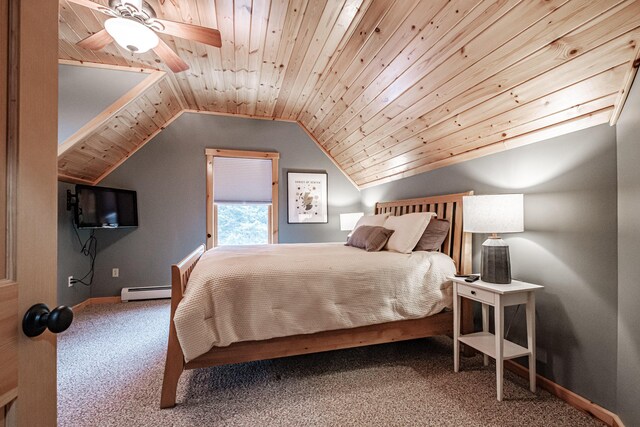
462 194 524 233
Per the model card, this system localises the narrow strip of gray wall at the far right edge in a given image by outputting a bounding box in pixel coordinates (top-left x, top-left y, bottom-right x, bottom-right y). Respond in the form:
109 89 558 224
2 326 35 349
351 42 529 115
616 78 640 426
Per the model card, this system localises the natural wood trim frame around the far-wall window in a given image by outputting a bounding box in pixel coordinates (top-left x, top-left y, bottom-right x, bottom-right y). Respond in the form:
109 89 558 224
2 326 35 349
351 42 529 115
204 148 280 249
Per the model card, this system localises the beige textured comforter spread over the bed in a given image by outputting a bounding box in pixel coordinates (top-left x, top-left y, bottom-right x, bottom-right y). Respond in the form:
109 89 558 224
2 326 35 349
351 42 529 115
174 243 455 360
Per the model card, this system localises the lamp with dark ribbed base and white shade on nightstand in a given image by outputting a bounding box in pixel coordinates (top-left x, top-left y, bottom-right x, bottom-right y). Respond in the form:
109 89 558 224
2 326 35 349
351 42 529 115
462 194 524 284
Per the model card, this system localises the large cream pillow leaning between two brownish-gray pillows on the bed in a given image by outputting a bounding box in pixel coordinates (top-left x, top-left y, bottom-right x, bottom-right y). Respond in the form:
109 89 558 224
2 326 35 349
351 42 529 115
383 212 436 254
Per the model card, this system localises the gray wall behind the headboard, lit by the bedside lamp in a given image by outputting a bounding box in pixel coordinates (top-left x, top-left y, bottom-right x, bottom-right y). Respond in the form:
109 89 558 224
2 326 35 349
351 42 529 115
362 125 616 408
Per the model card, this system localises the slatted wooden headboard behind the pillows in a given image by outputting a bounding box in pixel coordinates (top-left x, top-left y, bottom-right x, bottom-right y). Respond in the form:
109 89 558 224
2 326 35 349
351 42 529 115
375 191 473 274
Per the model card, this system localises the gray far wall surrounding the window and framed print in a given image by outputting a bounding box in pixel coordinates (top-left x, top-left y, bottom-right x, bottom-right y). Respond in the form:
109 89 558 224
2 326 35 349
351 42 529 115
59 113 360 300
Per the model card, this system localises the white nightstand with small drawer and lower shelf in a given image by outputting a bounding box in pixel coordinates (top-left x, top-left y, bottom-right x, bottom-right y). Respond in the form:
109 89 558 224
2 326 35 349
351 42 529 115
448 277 544 401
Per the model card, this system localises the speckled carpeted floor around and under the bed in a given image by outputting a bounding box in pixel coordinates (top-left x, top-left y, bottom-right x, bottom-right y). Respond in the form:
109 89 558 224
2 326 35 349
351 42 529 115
58 300 601 427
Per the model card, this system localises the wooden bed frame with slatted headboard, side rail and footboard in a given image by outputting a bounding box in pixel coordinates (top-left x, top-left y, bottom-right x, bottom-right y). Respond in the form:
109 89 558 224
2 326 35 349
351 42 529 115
160 191 473 408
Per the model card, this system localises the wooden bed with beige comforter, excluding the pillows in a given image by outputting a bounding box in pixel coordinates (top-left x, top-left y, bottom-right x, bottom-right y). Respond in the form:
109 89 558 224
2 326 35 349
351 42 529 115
161 192 472 408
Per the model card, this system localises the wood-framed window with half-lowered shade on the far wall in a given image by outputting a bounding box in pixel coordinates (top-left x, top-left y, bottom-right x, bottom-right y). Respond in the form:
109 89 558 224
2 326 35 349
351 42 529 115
205 149 279 248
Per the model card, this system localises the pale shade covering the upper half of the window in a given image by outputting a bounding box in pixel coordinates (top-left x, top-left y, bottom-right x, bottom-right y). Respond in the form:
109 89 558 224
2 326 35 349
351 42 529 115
213 157 271 203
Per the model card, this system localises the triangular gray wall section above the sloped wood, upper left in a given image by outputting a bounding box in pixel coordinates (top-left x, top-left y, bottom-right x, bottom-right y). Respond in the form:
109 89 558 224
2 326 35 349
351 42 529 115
58 65 148 143
